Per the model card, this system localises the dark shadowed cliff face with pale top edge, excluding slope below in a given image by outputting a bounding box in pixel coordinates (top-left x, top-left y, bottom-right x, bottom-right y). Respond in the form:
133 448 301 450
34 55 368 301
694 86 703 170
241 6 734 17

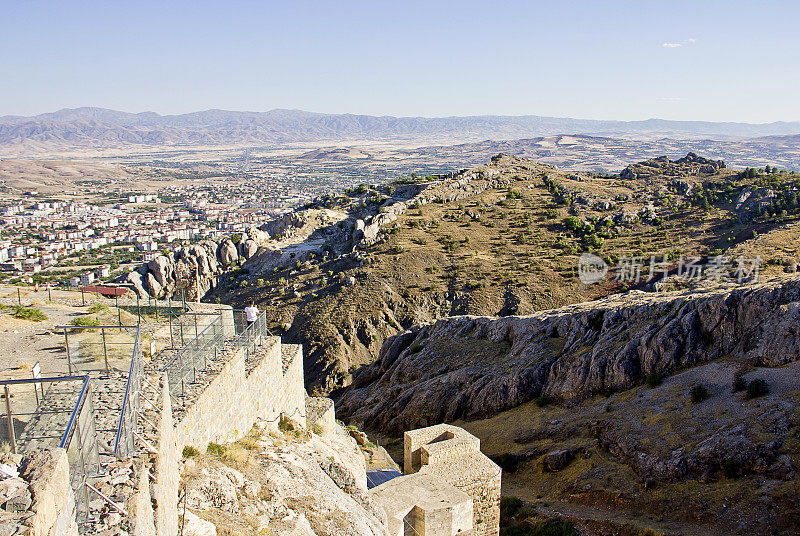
337 277 800 433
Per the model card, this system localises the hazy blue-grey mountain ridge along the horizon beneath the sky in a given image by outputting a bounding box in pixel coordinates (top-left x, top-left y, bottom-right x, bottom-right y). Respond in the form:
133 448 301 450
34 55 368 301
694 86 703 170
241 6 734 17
0 108 800 151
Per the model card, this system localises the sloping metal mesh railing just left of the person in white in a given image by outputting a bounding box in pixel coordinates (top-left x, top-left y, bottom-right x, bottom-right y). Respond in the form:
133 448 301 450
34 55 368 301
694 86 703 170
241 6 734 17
158 314 224 397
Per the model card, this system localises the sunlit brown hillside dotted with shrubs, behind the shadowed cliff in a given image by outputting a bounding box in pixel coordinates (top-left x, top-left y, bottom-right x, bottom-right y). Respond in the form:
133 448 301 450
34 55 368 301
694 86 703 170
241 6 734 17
214 154 800 393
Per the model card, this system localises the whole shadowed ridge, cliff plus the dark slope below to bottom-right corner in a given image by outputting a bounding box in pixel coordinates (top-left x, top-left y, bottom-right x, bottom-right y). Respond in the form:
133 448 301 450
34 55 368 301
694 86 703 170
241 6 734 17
337 276 800 535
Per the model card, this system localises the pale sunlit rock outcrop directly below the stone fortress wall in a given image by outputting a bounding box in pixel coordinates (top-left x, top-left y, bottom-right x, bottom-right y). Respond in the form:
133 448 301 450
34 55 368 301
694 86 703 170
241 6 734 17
183 425 388 536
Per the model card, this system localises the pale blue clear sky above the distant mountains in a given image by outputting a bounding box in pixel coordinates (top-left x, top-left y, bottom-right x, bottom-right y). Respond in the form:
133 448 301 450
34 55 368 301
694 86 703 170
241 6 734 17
0 0 800 123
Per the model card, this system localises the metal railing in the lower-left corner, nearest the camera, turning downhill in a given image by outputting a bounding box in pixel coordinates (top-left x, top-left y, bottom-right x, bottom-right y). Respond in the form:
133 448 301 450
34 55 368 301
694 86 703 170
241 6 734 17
0 376 100 523
